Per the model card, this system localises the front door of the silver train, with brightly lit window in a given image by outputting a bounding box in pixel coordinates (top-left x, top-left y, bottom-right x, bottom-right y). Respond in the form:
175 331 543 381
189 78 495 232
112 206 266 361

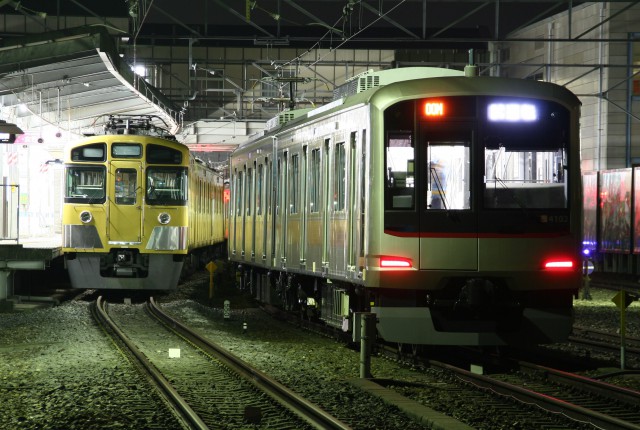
419 124 478 270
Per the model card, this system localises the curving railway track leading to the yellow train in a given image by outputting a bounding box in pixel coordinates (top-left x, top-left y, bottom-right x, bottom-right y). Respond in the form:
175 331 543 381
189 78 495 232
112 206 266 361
96 298 348 429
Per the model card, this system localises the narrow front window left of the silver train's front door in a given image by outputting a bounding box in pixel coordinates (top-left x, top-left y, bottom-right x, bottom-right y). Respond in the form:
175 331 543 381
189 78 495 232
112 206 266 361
385 132 415 210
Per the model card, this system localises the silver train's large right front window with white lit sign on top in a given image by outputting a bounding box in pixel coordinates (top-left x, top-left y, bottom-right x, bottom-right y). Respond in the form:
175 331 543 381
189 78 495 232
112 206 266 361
483 100 569 210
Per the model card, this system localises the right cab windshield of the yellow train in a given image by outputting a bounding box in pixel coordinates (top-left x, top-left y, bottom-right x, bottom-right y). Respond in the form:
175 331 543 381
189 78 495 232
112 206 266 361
145 166 189 206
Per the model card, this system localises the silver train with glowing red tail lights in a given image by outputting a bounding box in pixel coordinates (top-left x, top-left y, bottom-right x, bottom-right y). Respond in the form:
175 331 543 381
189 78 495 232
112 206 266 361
228 68 581 345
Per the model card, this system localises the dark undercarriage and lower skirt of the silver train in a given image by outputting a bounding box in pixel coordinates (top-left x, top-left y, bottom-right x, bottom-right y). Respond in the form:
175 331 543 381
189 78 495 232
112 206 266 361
238 266 573 345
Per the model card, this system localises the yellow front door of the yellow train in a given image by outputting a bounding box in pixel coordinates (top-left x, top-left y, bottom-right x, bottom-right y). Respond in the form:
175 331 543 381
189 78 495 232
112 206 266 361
107 161 143 245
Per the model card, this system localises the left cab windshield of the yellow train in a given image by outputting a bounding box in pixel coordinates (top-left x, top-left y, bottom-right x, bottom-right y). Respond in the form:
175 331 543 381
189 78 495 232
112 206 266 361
64 165 107 204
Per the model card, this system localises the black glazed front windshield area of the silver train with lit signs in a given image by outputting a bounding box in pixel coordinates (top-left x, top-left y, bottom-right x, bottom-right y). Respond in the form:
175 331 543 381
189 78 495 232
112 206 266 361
385 96 577 231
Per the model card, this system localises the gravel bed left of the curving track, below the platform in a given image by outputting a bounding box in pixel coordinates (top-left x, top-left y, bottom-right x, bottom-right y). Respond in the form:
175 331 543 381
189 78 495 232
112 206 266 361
0 302 181 430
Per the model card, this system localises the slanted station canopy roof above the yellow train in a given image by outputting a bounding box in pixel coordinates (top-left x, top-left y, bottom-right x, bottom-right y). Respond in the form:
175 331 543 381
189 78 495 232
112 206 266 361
0 26 180 134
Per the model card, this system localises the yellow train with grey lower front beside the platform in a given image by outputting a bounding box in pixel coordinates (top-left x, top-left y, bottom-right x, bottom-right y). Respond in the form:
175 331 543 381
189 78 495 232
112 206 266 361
62 116 225 290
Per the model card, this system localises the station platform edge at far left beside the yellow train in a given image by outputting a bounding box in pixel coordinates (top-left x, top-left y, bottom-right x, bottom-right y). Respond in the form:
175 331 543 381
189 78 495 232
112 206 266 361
0 235 62 312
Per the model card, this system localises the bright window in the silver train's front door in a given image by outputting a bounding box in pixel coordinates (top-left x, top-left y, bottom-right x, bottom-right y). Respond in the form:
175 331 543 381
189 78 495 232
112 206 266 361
425 138 471 210
